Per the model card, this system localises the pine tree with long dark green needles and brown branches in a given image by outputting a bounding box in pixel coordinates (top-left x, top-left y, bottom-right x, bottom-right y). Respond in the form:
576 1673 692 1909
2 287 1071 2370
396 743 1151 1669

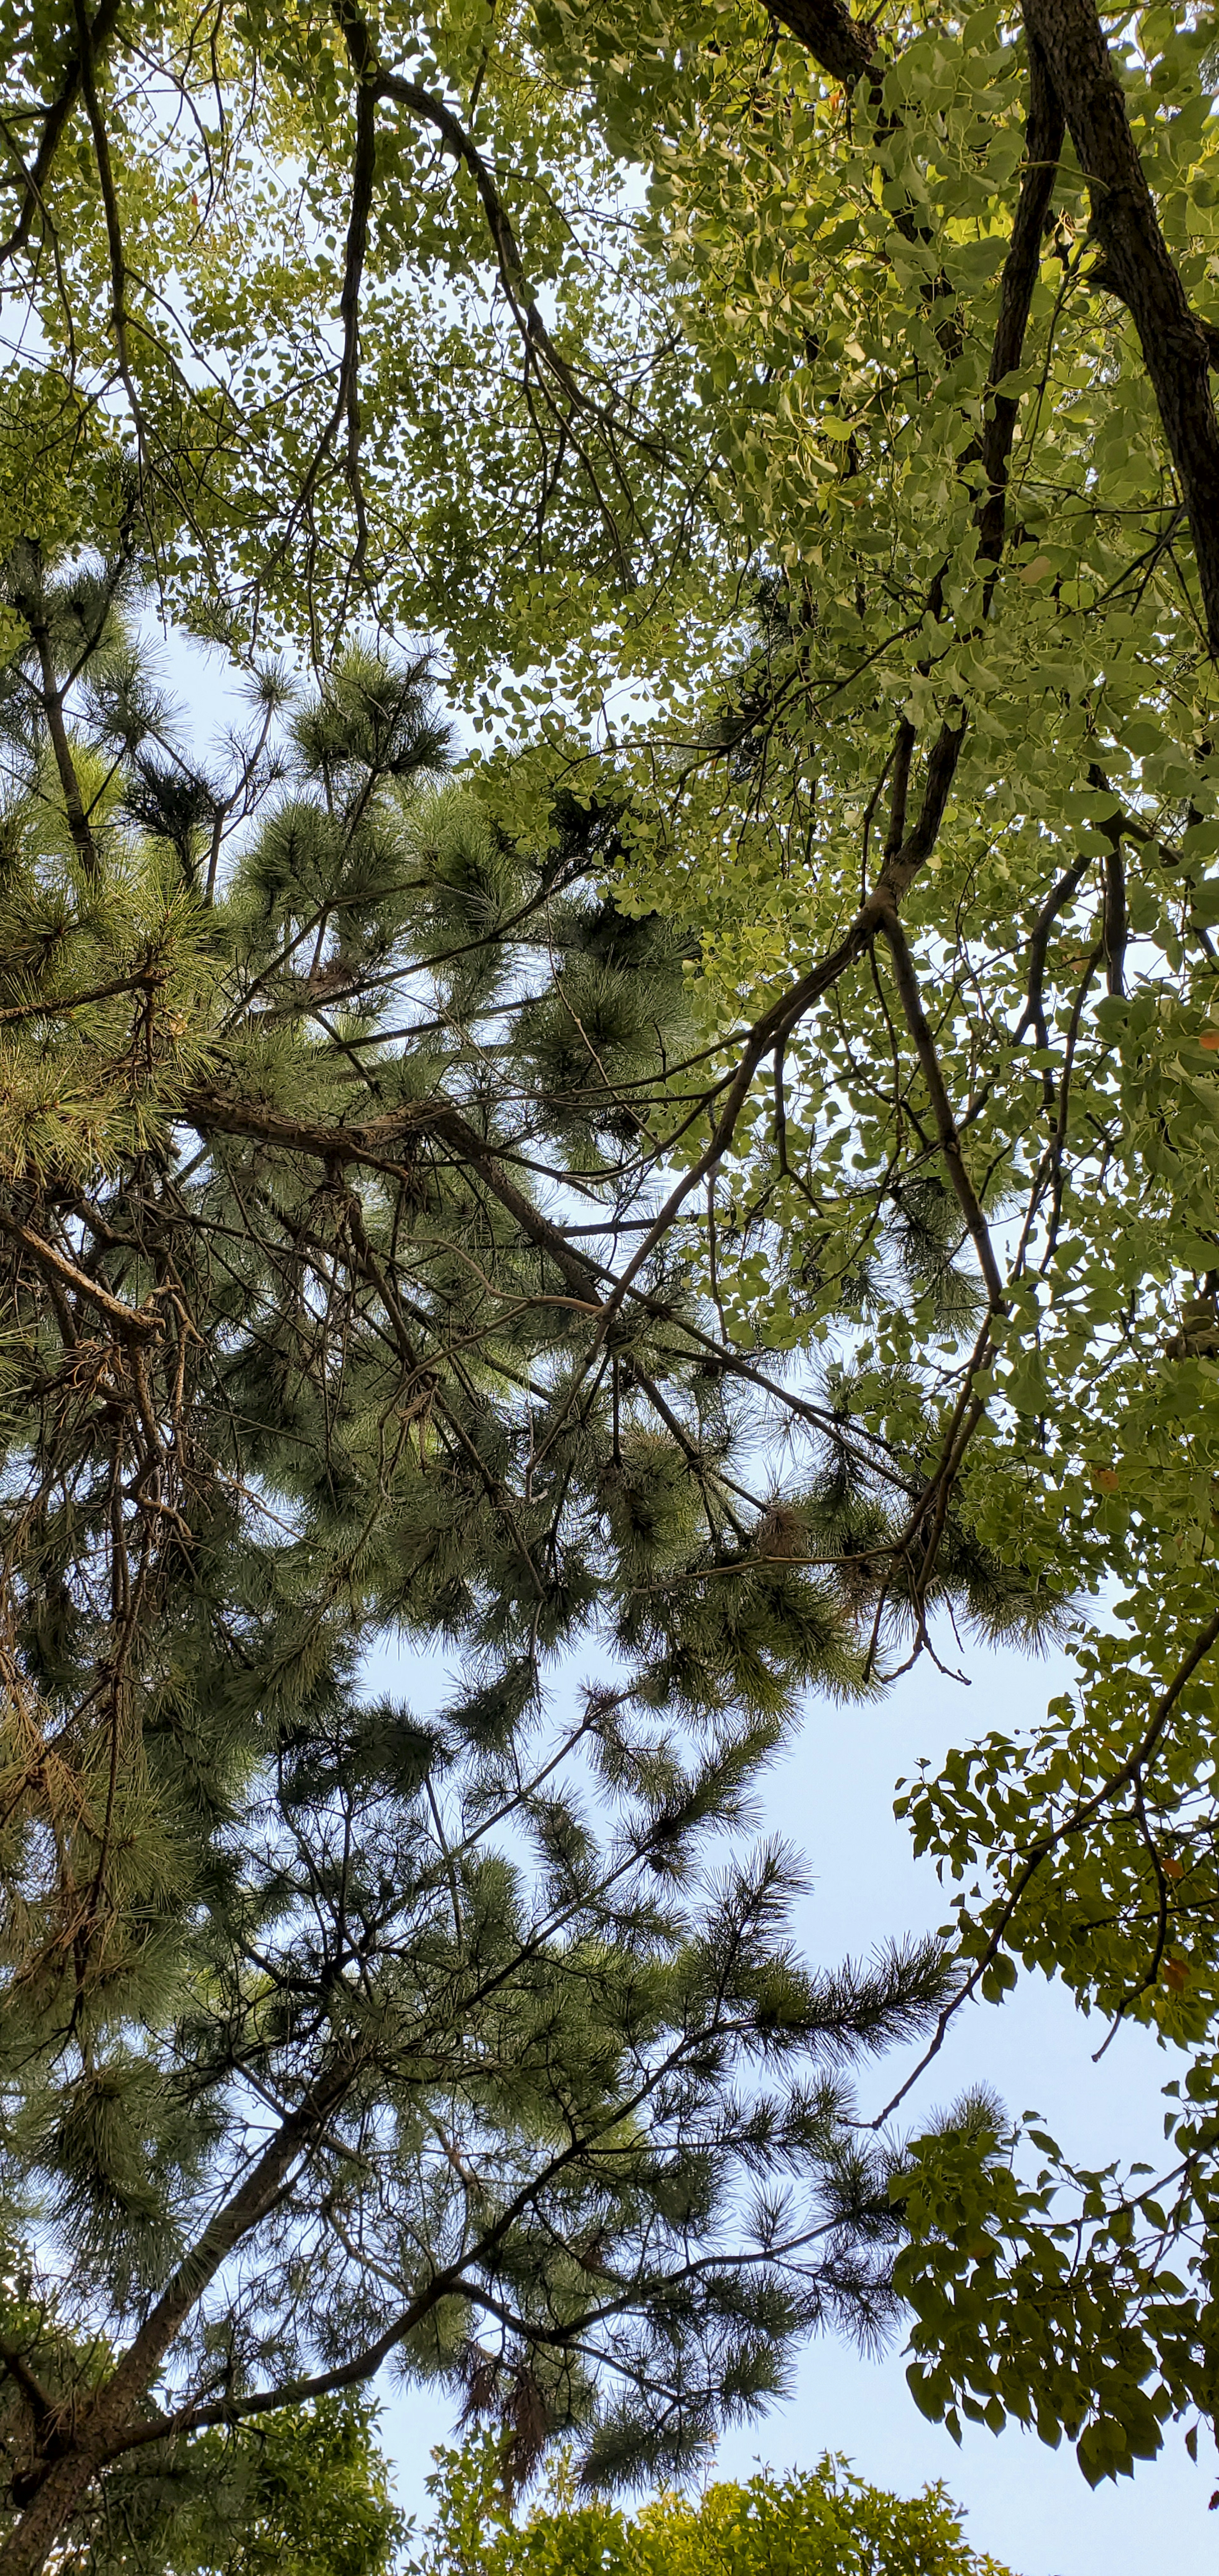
0 549 1049 2571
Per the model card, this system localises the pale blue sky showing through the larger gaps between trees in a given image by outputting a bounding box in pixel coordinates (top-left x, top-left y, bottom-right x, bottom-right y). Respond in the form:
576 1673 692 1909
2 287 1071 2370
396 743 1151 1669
157 636 1219 2576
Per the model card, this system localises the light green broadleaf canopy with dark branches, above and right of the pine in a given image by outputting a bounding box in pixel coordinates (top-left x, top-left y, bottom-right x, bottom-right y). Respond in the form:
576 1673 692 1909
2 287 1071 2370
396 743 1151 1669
0 0 1219 2524
